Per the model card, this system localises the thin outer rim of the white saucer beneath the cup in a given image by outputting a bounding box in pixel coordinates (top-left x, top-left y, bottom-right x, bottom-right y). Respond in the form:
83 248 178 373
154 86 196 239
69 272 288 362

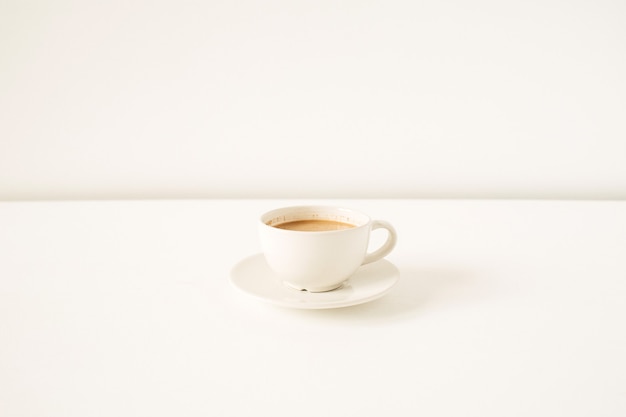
229 253 400 310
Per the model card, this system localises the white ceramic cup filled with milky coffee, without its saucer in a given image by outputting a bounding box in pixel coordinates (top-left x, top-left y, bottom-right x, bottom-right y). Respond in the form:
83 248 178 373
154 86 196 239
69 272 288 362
259 206 397 292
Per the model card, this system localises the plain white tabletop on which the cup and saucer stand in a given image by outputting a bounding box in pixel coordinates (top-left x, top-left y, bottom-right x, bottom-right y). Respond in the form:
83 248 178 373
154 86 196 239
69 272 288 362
0 200 626 417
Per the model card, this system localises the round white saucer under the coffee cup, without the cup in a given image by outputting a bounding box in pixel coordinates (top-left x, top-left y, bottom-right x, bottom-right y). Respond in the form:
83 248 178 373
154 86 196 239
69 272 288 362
230 254 400 309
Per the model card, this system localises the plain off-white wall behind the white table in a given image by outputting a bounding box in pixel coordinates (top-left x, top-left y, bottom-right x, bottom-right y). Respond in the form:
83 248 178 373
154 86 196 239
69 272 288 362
0 0 626 199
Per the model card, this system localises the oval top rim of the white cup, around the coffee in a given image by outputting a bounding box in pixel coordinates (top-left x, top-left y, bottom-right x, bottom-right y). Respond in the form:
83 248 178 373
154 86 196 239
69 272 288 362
259 204 371 235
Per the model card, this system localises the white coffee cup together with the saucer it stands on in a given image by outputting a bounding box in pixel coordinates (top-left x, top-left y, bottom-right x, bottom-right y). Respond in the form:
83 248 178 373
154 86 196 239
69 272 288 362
230 206 400 309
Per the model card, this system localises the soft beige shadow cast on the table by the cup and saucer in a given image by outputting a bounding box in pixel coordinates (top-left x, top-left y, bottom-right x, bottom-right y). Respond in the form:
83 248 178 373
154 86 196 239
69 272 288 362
286 268 486 322
